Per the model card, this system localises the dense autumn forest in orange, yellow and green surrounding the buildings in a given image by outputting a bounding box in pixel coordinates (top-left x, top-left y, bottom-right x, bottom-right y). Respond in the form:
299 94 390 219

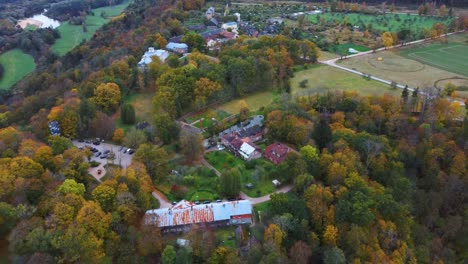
0 0 468 264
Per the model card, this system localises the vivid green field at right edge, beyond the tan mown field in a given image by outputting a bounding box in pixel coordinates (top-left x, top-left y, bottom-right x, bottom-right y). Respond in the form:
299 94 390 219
400 43 468 76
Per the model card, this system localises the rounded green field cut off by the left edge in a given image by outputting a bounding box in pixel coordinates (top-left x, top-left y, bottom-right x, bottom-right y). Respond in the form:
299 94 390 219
0 49 36 90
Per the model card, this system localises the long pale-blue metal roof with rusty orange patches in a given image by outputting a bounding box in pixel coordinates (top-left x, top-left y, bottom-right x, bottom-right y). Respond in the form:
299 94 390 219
145 200 252 227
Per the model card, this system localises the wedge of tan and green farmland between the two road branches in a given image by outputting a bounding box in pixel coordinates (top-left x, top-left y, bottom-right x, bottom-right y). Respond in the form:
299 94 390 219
338 33 468 92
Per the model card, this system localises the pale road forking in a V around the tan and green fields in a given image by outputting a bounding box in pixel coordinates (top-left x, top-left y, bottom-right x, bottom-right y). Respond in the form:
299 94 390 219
319 30 465 106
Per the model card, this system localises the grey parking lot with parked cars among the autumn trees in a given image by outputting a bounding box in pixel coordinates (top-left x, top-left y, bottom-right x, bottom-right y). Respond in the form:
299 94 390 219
72 140 134 181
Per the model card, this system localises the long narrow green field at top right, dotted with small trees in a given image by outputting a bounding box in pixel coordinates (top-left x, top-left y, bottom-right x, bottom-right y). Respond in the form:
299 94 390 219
309 13 451 32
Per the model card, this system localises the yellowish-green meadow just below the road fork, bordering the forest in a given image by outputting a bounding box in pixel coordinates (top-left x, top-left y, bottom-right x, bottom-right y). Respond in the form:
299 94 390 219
291 65 401 96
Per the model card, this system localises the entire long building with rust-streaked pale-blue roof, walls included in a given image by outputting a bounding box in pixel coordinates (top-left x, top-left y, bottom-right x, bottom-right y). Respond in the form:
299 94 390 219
144 200 252 232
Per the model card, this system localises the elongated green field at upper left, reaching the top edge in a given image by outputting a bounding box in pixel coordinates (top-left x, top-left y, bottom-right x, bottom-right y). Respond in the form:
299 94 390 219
52 0 131 56
